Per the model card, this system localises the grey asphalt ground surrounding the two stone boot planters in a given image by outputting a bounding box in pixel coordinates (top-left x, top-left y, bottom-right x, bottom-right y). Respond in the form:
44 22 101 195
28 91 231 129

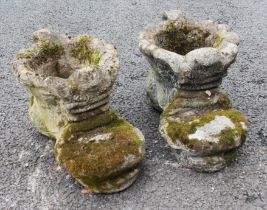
0 0 267 210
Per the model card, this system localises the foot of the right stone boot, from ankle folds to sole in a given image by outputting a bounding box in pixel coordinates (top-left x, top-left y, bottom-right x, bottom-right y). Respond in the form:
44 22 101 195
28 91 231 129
160 90 248 172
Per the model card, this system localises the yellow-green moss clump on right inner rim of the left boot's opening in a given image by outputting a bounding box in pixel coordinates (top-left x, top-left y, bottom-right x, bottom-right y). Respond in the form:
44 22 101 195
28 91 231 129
71 35 101 65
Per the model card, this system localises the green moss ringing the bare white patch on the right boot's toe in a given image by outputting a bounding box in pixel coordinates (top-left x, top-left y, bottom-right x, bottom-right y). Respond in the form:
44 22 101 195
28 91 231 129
166 109 247 154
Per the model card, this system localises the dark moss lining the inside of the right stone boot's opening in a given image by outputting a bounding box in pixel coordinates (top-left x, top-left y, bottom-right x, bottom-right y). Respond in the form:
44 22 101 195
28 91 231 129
156 21 209 55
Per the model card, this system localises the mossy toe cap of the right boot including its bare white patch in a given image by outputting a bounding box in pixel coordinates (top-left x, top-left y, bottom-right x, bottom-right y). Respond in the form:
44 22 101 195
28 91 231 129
161 109 247 155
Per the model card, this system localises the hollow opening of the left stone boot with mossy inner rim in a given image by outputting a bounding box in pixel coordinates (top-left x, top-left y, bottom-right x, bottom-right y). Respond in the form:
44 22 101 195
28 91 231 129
18 35 101 78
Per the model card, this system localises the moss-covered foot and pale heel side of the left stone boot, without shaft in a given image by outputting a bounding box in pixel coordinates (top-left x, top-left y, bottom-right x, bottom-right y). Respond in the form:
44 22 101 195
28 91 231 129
29 96 144 193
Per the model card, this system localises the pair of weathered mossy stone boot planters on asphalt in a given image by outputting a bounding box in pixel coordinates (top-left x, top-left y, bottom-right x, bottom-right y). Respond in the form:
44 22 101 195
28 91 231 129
13 11 247 193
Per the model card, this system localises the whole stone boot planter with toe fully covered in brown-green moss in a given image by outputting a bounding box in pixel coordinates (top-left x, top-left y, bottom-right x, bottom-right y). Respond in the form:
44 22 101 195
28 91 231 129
13 29 144 193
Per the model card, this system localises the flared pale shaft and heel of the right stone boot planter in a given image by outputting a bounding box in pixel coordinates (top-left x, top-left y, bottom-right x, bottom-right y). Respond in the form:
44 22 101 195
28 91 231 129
139 10 239 111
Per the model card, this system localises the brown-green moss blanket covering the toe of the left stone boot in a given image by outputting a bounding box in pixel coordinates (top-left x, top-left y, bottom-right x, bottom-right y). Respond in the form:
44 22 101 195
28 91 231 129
55 113 146 190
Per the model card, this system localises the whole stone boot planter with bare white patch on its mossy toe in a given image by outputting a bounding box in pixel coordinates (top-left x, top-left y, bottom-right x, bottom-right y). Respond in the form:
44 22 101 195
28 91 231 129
139 10 247 172
